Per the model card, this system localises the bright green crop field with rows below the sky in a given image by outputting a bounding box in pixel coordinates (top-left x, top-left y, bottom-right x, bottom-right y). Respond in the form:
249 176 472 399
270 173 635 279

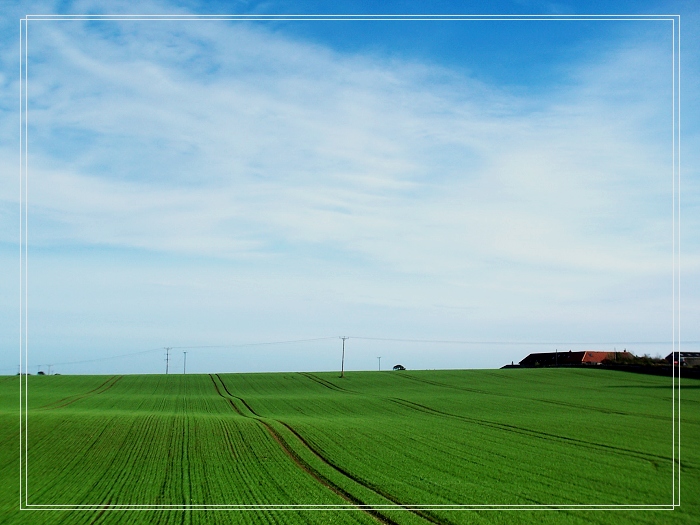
0 369 700 525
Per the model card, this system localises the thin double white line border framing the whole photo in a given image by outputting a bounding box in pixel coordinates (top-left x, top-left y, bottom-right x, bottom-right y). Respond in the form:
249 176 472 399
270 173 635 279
19 14 681 511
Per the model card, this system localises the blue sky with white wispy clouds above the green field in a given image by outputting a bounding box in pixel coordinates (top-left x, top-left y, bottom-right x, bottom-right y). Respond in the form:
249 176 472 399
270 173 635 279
0 2 700 373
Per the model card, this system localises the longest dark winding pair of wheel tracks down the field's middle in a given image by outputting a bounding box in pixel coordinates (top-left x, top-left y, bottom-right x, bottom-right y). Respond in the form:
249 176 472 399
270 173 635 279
210 374 450 525
